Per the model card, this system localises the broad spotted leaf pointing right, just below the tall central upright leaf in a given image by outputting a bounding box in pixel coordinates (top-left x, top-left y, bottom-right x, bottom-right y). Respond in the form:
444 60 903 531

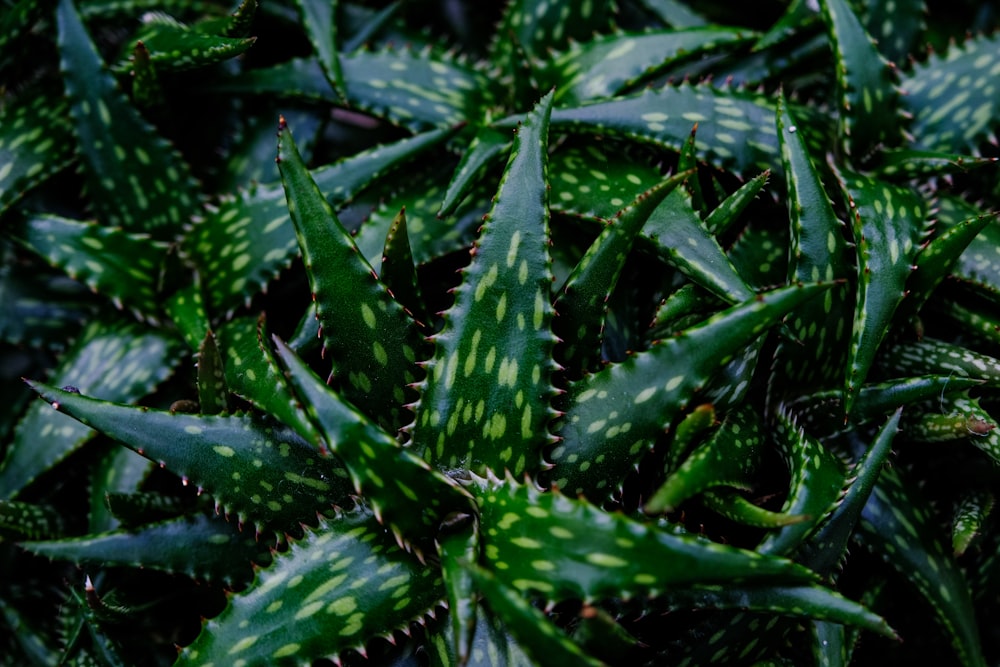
479 482 815 601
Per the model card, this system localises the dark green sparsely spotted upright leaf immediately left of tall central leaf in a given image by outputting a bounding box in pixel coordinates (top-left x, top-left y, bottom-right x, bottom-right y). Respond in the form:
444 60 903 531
278 124 422 430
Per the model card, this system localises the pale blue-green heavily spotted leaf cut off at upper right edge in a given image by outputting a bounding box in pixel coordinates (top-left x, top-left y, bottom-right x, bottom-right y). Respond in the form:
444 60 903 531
900 35 1000 153
